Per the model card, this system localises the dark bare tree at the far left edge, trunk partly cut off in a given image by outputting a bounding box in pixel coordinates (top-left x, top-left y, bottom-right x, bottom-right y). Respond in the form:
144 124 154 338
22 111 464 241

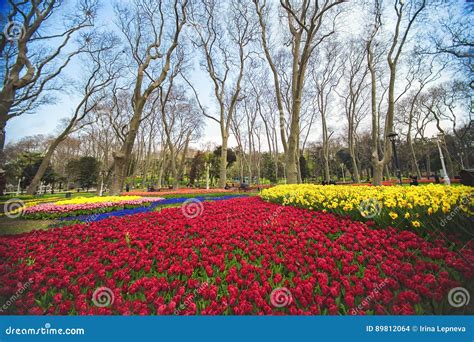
0 0 97 193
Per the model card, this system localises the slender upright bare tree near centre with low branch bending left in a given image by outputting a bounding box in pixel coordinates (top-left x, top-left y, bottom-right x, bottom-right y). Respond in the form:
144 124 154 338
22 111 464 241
184 0 254 187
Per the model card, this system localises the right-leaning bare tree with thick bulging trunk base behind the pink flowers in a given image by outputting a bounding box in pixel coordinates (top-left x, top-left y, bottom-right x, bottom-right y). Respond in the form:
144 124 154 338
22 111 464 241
110 0 187 194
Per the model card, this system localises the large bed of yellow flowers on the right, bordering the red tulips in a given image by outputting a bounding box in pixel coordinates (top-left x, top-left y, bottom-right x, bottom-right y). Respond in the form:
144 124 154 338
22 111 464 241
261 184 474 229
